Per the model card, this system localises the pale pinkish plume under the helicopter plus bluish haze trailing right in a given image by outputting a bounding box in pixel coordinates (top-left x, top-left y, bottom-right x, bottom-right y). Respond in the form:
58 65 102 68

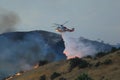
62 32 112 59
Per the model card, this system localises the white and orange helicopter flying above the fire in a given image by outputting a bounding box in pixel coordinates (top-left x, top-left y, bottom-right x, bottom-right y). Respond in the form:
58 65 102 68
54 21 75 33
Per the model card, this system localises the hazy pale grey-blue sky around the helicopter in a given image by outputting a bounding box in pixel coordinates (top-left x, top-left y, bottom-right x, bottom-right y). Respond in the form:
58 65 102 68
0 0 120 44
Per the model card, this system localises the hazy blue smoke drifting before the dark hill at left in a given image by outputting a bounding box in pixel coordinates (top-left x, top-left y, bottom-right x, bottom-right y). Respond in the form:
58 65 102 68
0 35 55 72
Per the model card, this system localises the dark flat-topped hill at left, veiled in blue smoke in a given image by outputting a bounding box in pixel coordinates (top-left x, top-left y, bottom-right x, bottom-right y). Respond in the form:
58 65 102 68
0 31 66 79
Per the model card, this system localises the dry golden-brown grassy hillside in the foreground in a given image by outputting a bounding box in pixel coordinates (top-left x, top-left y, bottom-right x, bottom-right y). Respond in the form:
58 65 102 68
6 50 120 80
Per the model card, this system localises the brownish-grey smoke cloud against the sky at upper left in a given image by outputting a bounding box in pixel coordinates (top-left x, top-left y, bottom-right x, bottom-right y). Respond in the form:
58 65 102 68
0 8 20 34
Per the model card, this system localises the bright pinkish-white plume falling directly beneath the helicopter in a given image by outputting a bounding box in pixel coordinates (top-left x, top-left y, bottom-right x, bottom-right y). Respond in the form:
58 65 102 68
62 32 96 59
